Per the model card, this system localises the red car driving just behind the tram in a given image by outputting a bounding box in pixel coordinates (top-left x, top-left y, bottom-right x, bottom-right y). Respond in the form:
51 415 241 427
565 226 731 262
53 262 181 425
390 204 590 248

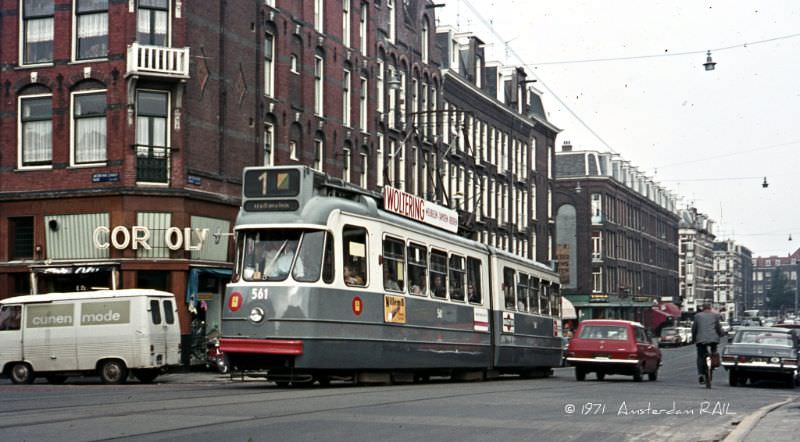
567 319 661 382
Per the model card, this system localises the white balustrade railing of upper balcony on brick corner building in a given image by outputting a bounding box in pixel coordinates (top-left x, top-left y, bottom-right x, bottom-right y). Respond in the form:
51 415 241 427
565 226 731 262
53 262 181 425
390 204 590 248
127 43 189 79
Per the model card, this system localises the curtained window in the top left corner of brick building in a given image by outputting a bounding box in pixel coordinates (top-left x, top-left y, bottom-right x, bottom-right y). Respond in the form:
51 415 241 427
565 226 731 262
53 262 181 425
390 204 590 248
22 0 55 64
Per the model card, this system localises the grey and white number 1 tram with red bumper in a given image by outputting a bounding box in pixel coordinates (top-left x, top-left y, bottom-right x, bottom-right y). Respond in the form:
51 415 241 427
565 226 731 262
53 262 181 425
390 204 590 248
220 166 561 385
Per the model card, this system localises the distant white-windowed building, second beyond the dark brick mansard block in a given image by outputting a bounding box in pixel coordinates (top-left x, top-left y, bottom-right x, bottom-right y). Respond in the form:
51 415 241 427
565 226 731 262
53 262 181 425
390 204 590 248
713 240 753 320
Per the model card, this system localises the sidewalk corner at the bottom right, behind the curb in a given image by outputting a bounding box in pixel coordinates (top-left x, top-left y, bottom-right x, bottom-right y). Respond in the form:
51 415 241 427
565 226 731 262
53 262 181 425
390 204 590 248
725 394 800 442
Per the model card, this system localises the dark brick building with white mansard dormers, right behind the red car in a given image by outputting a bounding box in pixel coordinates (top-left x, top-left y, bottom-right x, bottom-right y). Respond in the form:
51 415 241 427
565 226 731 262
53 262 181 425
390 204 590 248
555 147 678 322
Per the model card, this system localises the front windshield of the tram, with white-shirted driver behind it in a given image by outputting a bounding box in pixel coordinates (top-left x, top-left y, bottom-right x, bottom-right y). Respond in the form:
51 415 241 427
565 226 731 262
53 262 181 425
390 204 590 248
237 229 326 282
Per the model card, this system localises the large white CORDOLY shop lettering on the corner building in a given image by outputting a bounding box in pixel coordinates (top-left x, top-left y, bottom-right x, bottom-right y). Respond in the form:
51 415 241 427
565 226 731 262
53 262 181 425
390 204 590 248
92 226 209 251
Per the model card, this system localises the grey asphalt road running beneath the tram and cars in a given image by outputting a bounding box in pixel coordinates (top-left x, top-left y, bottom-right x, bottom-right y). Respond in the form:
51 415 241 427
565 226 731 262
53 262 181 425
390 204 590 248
0 346 797 442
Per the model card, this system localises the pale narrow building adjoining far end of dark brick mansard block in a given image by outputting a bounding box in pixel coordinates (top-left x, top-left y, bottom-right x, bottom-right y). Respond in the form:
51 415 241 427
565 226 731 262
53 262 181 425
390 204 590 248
678 207 715 314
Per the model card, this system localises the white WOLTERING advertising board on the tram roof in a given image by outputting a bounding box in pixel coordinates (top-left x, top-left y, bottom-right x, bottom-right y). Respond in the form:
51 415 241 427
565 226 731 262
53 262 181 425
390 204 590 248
383 186 458 233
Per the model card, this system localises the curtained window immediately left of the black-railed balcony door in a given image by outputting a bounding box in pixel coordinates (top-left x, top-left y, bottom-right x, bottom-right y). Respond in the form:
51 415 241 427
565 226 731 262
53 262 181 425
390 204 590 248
72 92 106 165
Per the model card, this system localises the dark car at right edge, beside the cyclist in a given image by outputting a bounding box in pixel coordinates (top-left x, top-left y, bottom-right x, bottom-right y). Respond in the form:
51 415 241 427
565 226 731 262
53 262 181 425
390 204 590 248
722 327 800 388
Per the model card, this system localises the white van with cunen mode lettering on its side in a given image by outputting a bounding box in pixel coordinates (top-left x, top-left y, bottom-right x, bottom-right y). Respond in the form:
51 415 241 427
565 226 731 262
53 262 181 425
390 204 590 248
0 289 180 384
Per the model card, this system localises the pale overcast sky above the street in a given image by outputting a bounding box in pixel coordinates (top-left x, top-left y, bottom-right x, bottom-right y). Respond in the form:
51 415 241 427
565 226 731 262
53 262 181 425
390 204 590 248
436 0 800 256
